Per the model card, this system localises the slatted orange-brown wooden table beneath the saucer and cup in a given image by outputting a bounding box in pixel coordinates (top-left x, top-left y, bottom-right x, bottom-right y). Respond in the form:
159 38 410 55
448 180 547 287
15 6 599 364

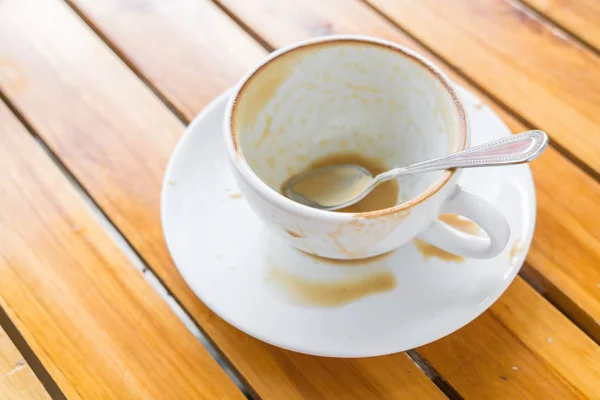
0 0 600 400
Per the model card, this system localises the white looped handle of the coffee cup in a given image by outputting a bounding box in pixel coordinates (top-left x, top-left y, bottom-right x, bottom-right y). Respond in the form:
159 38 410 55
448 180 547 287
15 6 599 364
419 186 510 258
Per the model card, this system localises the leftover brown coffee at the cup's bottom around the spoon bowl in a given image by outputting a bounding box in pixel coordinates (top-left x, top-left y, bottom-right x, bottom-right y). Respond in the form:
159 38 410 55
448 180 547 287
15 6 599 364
281 152 398 213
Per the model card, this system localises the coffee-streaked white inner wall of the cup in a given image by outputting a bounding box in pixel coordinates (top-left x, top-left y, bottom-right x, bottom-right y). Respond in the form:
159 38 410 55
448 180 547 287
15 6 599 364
232 40 465 208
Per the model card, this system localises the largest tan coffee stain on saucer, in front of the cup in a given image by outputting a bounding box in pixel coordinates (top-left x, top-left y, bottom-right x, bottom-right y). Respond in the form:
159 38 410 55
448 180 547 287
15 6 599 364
269 268 396 307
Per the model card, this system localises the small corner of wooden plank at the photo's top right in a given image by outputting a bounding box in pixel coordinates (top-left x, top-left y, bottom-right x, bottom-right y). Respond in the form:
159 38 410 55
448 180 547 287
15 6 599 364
521 0 600 49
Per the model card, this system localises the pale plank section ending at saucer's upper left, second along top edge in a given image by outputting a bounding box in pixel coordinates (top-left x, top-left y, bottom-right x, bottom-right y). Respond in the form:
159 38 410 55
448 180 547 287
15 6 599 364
69 0 264 119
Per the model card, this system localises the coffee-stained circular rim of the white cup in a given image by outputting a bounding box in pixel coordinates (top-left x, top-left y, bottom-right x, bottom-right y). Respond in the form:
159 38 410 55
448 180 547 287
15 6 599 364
224 35 469 221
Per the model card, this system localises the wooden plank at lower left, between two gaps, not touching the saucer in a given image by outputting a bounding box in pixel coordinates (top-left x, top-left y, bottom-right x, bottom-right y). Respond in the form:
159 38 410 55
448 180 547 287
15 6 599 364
0 103 243 399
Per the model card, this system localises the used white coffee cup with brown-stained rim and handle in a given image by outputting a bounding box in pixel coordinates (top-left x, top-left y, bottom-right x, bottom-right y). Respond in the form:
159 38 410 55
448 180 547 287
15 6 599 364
224 36 510 259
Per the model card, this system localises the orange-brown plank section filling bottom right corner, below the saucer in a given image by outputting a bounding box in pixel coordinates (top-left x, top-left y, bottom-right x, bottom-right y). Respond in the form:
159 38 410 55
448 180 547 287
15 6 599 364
417 278 600 400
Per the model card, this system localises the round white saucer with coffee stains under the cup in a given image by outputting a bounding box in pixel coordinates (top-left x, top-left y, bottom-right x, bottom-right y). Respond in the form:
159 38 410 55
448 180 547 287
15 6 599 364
161 87 535 357
